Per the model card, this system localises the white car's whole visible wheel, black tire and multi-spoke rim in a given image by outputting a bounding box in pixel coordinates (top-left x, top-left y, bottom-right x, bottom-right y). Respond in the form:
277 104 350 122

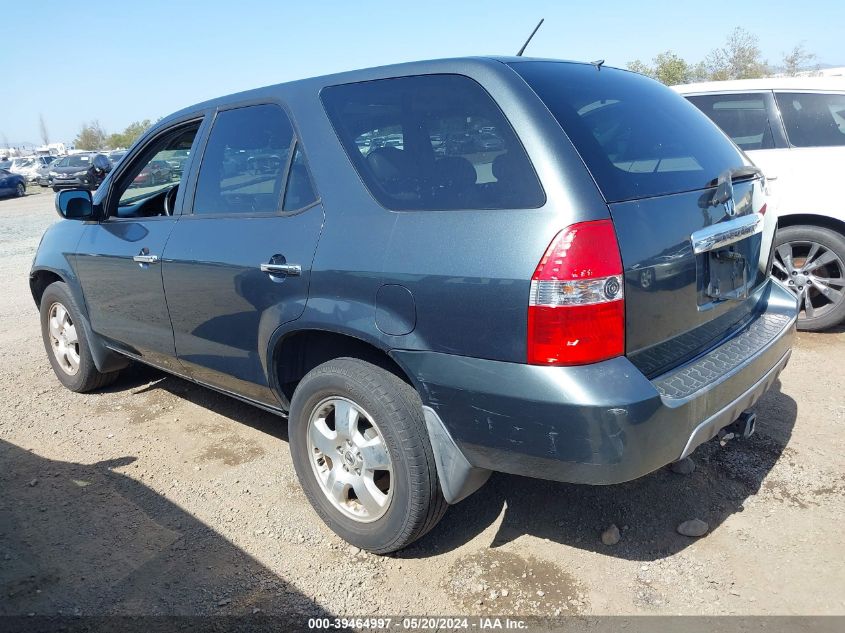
772 224 845 332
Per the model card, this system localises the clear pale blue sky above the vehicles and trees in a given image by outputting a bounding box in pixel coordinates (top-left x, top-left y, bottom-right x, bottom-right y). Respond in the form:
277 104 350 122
0 0 845 145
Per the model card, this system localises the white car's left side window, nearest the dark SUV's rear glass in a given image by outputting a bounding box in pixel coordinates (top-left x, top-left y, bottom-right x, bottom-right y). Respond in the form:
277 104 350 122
687 94 775 150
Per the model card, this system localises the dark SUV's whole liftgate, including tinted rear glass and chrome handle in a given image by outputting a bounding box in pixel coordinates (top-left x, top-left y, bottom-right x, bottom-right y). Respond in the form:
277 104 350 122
513 62 774 376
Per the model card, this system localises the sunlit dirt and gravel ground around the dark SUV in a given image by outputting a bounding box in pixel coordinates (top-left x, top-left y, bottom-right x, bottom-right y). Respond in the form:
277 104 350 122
0 187 845 616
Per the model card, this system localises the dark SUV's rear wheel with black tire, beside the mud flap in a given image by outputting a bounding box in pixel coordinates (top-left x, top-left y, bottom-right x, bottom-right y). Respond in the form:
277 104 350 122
288 358 448 554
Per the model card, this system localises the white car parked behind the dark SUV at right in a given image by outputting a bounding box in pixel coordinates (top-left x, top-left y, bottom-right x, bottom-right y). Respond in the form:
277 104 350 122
673 77 845 331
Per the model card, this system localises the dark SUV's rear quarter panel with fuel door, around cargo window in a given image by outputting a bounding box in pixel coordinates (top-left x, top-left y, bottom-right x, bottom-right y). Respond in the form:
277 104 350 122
285 60 609 362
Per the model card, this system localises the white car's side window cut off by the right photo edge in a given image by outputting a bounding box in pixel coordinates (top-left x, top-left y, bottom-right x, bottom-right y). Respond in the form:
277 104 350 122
775 93 845 147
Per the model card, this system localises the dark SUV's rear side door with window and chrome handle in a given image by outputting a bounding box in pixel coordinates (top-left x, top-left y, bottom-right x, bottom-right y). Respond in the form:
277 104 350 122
164 104 323 404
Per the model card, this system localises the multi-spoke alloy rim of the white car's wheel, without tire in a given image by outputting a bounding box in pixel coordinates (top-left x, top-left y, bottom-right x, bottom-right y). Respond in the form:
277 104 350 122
772 241 845 319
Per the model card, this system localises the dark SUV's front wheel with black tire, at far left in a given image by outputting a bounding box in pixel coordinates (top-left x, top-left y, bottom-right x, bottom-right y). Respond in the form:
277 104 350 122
40 281 120 393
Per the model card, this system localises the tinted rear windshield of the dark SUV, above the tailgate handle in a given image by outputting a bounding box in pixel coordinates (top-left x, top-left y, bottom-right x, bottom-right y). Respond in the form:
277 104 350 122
512 62 746 202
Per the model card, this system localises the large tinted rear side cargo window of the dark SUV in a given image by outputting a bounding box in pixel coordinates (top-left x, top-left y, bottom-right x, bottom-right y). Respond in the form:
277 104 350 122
322 75 545 210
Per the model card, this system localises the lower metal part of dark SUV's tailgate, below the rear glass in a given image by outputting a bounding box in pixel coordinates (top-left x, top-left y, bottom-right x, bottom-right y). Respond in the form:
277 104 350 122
609 180 774 376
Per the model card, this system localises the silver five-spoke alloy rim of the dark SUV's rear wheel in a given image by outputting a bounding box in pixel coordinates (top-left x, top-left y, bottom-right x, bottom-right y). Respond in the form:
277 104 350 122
308 397 393 523
